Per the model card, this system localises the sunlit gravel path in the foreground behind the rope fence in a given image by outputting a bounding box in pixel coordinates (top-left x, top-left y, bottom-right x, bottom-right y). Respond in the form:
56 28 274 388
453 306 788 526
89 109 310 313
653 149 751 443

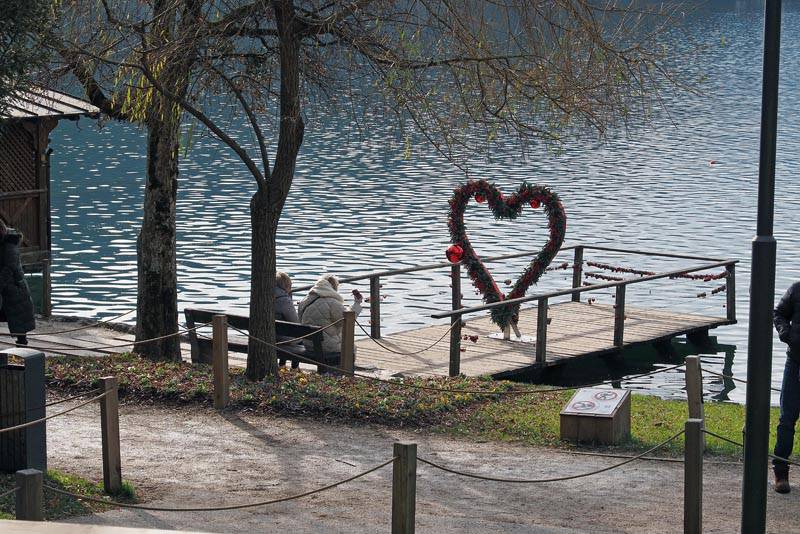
48 406 800 533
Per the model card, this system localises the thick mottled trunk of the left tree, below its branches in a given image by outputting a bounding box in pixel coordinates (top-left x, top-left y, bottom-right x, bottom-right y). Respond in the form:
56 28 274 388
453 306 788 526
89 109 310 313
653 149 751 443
134 114 181 361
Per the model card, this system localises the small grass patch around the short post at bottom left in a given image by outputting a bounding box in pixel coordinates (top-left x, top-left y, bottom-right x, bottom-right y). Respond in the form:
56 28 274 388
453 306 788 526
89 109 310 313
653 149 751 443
0 469 136 521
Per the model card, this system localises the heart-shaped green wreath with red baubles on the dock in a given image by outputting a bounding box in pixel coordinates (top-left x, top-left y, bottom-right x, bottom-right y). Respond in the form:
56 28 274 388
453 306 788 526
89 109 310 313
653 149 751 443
447 180 567 330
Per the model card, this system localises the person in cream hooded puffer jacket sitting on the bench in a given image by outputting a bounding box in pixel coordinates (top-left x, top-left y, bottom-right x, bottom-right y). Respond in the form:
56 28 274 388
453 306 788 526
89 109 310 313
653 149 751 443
297 274 362 364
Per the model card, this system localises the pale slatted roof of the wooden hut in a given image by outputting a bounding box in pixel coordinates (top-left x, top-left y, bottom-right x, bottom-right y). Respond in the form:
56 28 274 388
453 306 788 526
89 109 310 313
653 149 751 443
0 87 100 121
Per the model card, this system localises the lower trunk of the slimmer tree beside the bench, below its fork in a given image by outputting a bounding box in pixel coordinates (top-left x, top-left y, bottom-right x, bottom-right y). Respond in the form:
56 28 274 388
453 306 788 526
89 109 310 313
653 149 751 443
246 189 280 380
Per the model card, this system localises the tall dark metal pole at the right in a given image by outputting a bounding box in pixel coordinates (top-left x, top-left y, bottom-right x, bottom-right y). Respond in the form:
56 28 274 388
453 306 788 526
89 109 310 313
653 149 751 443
741 0 781 534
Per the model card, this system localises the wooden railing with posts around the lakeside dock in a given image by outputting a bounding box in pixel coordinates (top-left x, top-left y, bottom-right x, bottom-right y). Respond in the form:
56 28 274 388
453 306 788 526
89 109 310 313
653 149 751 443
295 245 738 376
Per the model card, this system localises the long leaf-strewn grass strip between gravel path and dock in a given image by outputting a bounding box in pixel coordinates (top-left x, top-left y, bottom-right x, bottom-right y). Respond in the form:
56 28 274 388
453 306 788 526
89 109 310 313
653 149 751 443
47 354 800 458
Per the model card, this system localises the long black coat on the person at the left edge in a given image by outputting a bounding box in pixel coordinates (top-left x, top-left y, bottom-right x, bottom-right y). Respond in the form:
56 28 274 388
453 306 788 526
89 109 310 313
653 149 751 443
0 231 36 334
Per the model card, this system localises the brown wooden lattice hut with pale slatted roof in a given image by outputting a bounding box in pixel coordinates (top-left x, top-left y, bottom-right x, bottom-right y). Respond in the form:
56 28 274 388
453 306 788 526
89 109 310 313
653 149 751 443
0 88 99 316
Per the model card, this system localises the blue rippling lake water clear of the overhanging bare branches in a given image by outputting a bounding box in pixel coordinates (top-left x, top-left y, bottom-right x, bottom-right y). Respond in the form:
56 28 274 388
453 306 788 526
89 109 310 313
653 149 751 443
45 1 800 402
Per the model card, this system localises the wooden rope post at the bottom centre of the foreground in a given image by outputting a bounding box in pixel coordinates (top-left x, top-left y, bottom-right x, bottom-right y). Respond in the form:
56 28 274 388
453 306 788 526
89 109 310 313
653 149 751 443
392 443 417 534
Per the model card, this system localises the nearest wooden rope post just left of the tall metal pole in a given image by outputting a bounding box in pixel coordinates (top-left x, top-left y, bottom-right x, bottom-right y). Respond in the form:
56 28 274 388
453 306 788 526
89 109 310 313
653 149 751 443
683 419 703 534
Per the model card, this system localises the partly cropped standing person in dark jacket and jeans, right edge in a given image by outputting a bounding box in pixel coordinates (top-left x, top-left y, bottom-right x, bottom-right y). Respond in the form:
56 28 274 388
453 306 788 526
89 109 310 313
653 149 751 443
772 282 800 493
